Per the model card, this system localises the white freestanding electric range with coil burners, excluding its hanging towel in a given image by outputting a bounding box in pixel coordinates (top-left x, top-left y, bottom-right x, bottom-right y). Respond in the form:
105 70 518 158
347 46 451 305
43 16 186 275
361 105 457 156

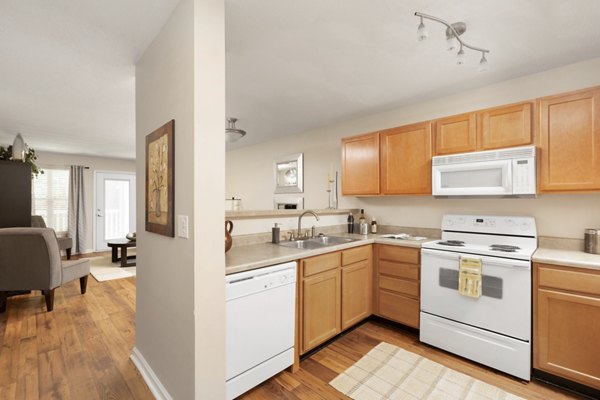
420 215 537 380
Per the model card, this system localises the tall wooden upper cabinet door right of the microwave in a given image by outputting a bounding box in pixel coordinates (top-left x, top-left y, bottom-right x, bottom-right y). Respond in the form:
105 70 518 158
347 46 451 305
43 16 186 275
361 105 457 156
538 88 600 192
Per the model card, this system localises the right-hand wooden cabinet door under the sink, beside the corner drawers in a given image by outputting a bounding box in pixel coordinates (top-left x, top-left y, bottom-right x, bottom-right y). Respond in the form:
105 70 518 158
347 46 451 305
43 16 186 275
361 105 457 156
342 261 372 330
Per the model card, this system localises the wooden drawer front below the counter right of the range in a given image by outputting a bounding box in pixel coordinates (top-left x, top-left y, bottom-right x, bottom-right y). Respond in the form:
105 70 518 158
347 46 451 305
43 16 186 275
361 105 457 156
537 264 600 296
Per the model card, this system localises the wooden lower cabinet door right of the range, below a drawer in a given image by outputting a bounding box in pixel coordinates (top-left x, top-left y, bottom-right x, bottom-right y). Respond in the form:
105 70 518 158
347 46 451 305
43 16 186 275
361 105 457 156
534 289 600 389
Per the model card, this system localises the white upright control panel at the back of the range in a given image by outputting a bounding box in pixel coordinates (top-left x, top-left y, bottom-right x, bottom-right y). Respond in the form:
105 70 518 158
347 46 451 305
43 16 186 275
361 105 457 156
442 214 537 237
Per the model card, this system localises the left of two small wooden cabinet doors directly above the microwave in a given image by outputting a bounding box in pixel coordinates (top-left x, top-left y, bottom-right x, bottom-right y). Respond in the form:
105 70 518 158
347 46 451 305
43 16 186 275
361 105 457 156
435 113 477 155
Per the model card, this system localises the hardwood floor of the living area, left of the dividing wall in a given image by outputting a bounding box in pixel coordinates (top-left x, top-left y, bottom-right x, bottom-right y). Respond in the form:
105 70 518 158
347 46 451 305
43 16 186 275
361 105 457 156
0 277 154 400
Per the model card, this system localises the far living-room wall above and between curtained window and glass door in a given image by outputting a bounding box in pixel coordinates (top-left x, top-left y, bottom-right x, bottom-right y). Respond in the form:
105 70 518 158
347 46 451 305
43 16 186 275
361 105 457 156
36 152 135 253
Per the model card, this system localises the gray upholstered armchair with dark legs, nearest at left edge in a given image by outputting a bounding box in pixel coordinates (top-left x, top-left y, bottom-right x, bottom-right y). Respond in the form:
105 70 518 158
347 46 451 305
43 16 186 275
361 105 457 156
0 228 90 312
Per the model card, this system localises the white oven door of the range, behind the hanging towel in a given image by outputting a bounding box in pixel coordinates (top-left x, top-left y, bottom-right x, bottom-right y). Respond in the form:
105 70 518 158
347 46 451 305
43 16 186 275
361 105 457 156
421 249 531 341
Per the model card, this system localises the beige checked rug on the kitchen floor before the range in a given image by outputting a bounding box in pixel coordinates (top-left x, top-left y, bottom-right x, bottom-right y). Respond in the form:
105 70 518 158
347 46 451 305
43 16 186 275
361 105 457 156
329 342 523 400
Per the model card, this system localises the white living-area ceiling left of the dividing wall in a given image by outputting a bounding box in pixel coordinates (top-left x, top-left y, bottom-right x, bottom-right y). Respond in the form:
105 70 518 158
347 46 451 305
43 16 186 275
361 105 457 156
0 0 178 158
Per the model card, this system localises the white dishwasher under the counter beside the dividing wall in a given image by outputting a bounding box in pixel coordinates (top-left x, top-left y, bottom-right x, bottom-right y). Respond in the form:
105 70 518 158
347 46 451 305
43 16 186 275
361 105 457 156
225 261 296 400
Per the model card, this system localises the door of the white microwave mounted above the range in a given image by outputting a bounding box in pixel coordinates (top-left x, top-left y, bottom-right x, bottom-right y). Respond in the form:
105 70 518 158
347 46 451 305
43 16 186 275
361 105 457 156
432 160 513 196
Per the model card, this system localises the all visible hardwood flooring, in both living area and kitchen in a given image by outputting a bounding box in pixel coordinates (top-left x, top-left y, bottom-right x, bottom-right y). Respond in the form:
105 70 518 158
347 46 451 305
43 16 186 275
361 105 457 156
0 262 592 400
